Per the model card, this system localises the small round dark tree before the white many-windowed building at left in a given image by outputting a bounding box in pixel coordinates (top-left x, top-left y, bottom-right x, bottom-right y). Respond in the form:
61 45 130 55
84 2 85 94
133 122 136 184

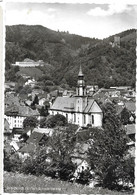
23 116 38 128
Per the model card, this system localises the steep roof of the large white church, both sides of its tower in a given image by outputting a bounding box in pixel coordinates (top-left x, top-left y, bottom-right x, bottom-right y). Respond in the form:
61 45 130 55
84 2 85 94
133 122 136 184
51 97 102 113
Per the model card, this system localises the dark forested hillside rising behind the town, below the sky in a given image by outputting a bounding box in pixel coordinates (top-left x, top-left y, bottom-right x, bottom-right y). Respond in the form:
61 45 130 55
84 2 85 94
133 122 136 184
5 25 136 88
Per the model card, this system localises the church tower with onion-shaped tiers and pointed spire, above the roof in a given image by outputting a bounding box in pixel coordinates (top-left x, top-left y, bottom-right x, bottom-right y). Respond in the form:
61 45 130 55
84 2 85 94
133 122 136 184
76 66 86 97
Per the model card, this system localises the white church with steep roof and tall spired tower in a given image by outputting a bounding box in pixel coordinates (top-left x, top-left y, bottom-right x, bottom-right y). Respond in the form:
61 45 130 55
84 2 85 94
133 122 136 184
49 67 103 127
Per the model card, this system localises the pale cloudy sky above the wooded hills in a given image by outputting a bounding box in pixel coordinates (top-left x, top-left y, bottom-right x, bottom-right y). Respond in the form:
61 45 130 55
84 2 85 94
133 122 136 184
5 0 137 39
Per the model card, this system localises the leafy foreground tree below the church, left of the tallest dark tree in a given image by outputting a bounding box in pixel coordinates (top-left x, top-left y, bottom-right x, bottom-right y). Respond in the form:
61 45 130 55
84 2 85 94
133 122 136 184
44 124 78 180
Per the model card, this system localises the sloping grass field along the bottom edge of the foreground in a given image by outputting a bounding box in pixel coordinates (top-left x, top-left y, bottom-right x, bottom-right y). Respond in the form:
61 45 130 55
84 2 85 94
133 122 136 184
4 172 133 195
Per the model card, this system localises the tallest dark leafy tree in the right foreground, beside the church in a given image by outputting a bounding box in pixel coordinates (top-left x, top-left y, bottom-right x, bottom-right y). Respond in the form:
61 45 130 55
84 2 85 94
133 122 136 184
88 103 131 189
